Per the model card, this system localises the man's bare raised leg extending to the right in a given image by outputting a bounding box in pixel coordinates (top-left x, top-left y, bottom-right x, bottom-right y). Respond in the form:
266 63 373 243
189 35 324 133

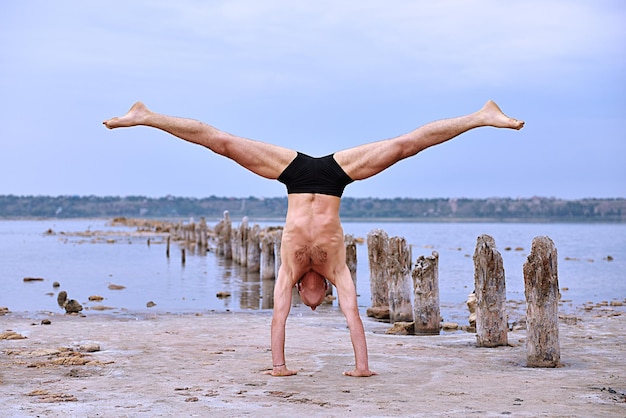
335 100 524 180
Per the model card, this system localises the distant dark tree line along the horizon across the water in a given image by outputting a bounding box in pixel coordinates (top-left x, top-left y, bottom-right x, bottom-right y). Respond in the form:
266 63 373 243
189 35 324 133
0 195 626 222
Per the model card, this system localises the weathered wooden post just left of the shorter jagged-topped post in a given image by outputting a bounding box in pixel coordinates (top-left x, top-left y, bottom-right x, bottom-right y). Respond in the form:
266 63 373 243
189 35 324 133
386 237 413 324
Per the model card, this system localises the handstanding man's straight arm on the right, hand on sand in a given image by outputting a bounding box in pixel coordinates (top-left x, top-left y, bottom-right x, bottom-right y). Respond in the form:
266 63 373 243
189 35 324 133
335 266 378 377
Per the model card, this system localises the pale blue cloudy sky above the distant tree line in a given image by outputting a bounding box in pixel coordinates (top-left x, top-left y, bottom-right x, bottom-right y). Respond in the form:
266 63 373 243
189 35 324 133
0 0 626 199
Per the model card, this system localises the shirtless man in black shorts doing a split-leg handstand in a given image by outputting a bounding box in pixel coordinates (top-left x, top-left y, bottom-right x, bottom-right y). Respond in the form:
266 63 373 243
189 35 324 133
104 101 524 377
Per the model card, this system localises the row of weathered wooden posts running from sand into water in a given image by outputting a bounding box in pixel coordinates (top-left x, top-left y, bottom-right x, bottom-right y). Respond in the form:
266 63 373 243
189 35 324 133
167 212 560 367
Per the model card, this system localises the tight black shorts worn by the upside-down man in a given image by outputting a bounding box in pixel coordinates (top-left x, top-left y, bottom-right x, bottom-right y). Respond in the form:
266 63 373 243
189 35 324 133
278 152 353 197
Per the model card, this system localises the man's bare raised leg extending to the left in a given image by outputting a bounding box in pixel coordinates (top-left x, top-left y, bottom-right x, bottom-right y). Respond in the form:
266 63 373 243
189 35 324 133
104 102 297 179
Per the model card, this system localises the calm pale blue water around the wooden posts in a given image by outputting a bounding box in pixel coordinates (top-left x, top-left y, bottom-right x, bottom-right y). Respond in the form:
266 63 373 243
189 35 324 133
0 219 626 320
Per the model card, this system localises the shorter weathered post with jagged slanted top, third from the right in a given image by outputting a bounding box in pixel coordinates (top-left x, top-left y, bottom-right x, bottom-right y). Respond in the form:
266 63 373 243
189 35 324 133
411 251 441 334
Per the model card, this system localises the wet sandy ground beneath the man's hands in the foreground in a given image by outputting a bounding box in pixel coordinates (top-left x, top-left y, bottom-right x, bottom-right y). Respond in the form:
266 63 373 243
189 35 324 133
0 307 626 417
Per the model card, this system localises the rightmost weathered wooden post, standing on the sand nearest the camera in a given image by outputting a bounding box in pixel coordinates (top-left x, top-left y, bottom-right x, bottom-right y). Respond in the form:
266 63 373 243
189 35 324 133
524 237 561 367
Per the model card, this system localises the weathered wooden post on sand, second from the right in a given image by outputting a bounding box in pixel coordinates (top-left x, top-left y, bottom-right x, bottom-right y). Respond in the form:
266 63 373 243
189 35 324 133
474 235 509 347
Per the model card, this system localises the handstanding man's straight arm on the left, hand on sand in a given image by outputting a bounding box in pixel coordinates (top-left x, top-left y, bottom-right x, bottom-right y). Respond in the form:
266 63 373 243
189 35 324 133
269 268 298 376
